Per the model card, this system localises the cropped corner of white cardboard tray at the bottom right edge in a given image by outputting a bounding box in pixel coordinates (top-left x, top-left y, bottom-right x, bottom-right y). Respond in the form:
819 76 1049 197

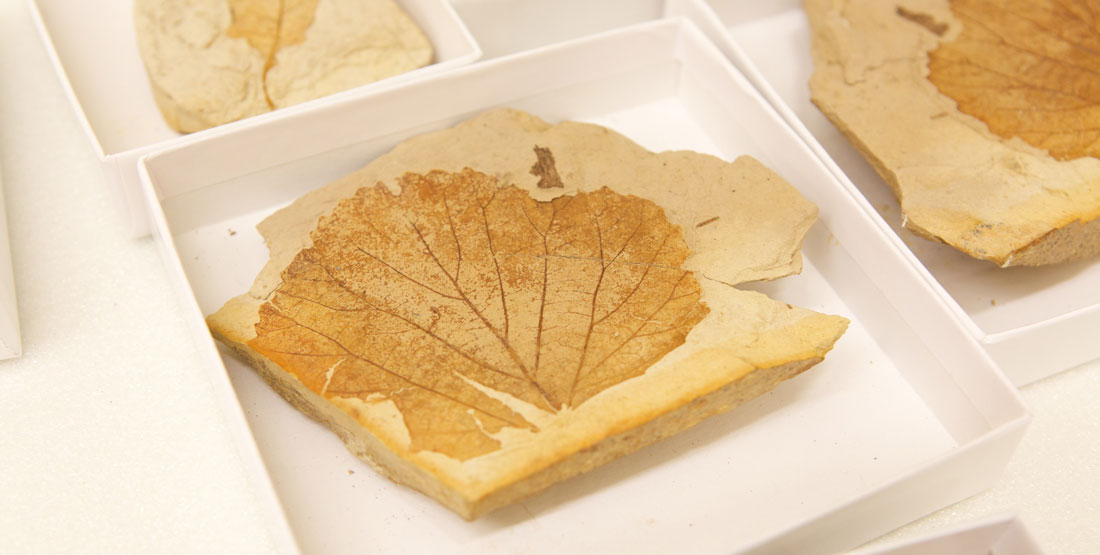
848 514 1045 555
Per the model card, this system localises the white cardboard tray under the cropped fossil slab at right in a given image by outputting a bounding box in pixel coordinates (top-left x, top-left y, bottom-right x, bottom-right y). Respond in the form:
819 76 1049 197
710 0 1100 386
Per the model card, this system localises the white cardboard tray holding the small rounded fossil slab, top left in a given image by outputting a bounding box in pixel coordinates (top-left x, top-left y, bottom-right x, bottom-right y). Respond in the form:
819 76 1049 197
29 0 482 236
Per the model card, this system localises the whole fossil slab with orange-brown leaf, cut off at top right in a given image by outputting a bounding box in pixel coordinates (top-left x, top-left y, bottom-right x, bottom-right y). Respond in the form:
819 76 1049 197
804 0 1100 266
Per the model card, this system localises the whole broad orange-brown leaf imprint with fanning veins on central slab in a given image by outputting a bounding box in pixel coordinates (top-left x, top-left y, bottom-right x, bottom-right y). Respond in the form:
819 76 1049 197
249 165 707 459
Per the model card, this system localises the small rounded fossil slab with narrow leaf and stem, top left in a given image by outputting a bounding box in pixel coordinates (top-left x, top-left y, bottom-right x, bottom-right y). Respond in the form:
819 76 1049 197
134 0 432 132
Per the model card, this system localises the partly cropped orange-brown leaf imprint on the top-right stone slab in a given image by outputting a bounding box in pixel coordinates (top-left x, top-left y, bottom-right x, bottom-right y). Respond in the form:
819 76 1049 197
928 0 1100 160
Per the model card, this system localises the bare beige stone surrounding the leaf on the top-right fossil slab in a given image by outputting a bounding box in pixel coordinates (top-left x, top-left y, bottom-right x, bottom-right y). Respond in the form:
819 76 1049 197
805 0 1100 266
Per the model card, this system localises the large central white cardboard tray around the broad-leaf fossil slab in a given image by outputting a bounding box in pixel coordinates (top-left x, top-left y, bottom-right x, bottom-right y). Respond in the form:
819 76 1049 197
141 19 1029 553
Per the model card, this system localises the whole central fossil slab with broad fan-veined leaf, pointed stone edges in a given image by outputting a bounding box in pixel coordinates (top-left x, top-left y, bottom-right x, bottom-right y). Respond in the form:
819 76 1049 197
207 109 847 519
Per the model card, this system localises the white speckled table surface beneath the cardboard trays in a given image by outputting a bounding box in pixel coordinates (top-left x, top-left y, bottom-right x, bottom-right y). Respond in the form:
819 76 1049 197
0 0 1100 554
